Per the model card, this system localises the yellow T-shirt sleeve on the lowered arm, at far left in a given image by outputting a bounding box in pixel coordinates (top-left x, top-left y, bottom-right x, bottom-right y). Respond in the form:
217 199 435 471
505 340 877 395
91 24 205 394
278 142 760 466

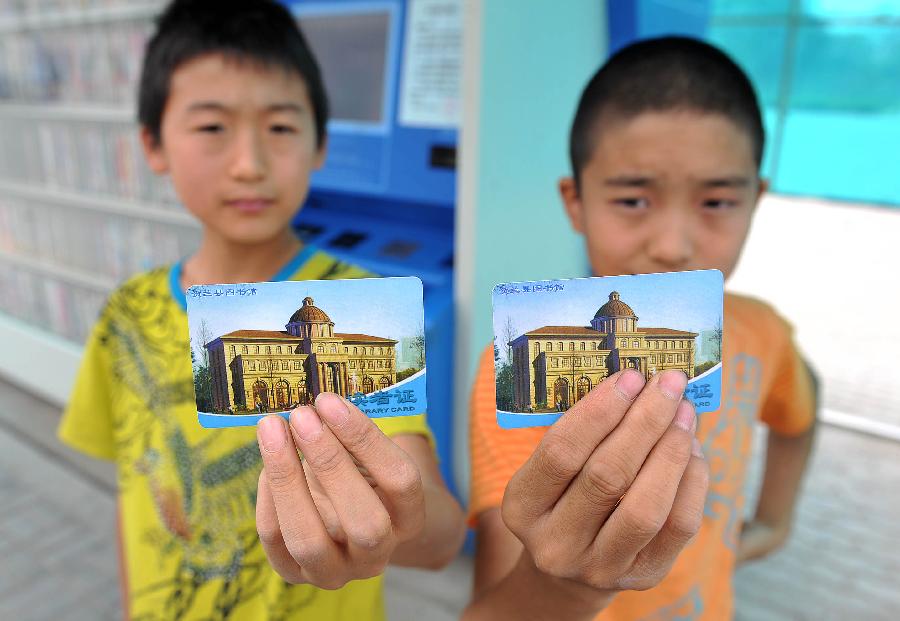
57 310 116 460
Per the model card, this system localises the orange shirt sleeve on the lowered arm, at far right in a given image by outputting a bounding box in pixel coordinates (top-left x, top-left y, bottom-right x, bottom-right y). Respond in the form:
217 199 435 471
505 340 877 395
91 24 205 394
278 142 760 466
760 315 816 436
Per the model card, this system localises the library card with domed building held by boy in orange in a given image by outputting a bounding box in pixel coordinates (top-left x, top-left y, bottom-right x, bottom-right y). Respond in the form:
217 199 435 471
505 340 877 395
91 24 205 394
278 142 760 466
493 270 724 429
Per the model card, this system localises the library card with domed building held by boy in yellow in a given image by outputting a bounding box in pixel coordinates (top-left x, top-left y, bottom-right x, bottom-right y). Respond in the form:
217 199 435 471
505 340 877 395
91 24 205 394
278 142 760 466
187 277 426 428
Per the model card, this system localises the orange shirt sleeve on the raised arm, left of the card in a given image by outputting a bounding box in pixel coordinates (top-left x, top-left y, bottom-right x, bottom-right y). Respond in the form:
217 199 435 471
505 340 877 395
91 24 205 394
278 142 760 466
468 347 545 527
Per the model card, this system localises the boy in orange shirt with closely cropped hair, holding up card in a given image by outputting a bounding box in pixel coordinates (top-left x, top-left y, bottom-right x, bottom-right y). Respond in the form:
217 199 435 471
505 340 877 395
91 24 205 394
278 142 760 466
464 37 816 620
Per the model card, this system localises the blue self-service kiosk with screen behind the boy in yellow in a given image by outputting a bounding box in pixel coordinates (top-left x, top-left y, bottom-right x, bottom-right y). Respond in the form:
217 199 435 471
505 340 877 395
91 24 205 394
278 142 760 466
285 0 462 489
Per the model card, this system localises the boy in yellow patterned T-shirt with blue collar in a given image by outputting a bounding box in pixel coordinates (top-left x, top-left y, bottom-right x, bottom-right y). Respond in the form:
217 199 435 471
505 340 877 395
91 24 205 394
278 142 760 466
59 0 464 621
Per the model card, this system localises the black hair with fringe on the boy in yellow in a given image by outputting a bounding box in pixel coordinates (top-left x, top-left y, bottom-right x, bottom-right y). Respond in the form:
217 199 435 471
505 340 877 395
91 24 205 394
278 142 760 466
138 0 328 146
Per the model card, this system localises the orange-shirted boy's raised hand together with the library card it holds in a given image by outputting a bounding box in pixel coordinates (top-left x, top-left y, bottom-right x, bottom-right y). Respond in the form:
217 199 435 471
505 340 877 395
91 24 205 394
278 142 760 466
478 270 723 618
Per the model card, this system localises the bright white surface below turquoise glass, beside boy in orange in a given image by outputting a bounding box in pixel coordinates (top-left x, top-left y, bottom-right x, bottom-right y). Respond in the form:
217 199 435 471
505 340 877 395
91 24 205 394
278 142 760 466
728 196 900 427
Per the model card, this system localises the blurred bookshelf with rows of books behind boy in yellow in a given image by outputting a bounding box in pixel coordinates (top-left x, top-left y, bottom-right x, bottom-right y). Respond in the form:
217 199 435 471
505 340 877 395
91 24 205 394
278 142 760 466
0 0 200 404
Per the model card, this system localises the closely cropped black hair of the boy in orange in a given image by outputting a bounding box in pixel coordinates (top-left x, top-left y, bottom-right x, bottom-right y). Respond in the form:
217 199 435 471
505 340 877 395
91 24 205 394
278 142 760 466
569 37 765 183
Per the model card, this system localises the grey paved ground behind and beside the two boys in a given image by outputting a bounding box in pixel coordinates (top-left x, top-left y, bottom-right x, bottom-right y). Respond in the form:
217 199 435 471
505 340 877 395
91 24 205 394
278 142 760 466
0 382 900 621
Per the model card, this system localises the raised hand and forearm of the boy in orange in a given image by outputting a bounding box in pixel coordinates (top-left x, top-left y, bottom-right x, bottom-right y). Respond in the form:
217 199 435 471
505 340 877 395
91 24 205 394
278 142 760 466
463 372 708 621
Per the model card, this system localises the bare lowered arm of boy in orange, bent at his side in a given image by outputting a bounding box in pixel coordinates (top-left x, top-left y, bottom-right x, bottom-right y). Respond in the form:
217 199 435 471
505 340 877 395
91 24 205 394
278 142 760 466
737 362 818 563
